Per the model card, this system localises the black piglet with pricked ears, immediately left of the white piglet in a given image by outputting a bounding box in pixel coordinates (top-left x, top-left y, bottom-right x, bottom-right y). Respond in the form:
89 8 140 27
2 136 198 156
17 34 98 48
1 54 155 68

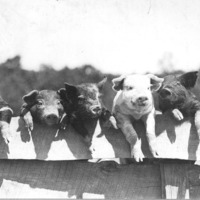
58 78 109 144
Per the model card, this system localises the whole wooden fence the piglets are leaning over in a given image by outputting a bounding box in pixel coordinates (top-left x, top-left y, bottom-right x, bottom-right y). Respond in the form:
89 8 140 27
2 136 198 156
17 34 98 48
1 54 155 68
0 111 200 199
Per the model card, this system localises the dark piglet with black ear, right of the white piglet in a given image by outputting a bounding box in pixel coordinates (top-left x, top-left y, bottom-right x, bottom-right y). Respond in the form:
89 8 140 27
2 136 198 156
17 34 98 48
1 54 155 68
158 71 200 144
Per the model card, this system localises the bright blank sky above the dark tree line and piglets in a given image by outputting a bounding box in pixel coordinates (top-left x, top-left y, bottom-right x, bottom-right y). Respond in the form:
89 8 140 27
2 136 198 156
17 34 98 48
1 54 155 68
0 0 200 73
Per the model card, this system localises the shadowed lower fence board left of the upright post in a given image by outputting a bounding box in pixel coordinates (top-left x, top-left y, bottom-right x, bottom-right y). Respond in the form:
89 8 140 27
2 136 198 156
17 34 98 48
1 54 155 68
0 160 161 199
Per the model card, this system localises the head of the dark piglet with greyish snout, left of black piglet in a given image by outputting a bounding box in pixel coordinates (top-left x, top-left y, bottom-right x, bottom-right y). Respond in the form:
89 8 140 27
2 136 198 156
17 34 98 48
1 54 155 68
22 90 64 126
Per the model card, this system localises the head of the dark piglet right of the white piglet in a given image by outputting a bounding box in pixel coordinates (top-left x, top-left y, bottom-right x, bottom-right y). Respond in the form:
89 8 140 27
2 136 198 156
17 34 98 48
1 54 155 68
158 71 198 112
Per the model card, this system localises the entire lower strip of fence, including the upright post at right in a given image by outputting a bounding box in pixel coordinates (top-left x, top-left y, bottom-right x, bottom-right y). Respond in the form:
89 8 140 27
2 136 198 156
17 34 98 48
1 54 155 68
0 160 200 199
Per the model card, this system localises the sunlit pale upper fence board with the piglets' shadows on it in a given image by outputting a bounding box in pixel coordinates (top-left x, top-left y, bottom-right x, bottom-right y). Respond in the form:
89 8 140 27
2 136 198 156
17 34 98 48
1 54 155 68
0 111 200 160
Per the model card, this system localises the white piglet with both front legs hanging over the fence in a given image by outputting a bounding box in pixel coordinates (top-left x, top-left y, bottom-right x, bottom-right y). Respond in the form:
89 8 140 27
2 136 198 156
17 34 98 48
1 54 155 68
113 74 163 162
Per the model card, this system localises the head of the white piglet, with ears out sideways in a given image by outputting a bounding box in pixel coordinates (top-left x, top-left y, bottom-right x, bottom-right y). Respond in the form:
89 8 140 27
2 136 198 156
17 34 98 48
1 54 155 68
113 74 163 112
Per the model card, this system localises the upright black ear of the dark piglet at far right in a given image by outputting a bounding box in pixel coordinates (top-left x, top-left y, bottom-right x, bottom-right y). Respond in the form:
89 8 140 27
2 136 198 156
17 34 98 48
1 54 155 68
178 71 198 89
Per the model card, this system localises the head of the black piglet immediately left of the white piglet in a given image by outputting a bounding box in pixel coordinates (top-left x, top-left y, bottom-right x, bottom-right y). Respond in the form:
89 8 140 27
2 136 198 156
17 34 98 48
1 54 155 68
58 78 107 119
